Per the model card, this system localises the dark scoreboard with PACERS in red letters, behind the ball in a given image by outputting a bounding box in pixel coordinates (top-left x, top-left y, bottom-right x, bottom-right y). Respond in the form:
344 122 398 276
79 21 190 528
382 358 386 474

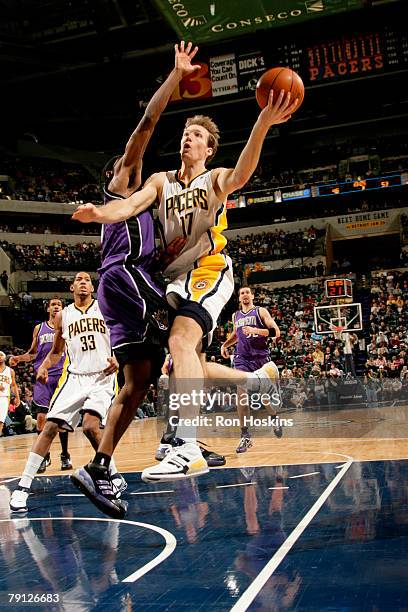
168 26 408 101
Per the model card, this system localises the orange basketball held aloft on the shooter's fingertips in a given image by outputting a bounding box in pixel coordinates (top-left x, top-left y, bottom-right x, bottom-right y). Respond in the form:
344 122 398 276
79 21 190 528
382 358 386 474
255 66 305 110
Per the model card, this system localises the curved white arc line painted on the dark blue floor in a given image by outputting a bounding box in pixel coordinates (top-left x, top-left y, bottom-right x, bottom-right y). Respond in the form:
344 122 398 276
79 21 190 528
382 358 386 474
0 516 177 582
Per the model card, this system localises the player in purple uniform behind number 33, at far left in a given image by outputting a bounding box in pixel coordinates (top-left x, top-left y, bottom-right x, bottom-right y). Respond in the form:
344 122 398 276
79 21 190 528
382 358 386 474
10 298 72 474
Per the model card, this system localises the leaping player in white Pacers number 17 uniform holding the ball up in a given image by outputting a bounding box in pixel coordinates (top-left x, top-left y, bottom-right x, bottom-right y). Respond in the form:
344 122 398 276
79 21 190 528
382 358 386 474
73 91 298 482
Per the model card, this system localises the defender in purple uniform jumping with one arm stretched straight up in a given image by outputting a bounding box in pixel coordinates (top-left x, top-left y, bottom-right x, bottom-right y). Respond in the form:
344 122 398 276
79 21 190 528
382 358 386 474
72 41 206 518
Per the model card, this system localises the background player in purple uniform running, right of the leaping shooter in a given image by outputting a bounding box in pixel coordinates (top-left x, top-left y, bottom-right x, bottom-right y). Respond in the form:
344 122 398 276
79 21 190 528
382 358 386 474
221 287 282 453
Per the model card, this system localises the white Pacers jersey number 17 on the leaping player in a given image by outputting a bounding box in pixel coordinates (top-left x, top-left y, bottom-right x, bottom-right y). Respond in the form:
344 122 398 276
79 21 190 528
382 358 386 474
158 170 227 280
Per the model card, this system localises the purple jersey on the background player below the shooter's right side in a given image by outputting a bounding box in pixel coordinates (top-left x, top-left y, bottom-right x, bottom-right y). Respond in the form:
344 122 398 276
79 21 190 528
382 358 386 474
234 306 269 360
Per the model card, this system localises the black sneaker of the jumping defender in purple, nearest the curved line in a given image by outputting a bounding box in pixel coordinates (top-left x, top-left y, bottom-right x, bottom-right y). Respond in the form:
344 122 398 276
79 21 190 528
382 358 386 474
70 463 128 519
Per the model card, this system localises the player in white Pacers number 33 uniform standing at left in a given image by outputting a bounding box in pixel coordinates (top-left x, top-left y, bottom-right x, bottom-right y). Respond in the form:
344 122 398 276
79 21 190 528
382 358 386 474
10 272 121 512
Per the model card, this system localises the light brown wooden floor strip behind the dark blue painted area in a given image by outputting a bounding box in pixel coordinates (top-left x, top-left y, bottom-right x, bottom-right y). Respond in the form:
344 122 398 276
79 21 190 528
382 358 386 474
0 406 408 478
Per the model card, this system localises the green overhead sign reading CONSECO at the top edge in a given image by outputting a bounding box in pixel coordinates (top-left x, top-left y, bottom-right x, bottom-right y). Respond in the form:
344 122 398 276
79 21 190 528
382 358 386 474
155 0 364 43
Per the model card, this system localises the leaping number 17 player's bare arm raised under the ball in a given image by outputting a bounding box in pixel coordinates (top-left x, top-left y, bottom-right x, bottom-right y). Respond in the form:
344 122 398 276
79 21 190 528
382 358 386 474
214 89 298 197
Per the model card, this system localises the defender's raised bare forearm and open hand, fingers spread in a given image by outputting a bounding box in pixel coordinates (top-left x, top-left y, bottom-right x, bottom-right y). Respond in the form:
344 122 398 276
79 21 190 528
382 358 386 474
119 40 200 171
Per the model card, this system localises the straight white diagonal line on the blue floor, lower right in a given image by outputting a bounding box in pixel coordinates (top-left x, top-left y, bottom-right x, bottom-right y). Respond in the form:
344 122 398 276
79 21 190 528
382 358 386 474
230 457 353 612
